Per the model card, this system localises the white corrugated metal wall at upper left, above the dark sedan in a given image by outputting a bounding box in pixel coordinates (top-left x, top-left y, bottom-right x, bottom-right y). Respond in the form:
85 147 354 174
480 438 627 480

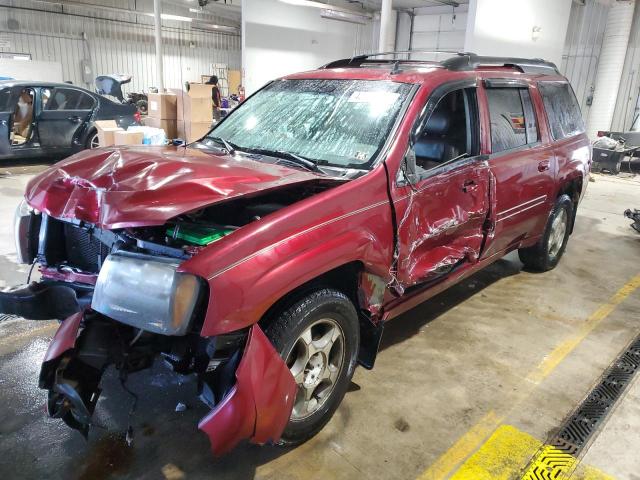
0 0 241 91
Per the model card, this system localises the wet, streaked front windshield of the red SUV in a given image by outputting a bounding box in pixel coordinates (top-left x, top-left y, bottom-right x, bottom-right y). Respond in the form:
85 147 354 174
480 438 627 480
209 80 411 168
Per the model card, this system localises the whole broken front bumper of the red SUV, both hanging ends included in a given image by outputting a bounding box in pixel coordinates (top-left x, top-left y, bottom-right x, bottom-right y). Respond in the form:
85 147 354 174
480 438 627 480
35 310 296 455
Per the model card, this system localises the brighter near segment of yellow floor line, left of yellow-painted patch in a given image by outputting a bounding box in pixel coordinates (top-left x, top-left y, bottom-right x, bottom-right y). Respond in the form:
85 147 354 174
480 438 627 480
418 410 504 480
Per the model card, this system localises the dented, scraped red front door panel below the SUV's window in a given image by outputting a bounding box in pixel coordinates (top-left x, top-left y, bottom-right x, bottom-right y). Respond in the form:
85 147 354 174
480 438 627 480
396 157 490 288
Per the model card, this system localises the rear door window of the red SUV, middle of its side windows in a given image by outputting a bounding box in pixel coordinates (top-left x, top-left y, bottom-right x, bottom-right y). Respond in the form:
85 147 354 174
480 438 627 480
486 87 538 153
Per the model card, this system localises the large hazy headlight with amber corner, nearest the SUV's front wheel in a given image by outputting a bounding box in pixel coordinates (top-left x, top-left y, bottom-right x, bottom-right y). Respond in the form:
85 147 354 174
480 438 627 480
91 252 200 335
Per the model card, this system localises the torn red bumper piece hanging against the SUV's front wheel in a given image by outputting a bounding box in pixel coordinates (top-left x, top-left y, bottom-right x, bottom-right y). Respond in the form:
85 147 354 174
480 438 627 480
198 325 297 455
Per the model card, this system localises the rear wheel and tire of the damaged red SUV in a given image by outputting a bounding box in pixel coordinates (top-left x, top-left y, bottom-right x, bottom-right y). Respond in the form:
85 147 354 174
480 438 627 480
518 195 574 272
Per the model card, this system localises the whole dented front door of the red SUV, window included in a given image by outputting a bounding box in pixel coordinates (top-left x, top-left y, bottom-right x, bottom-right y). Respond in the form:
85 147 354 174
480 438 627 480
395 83 490 288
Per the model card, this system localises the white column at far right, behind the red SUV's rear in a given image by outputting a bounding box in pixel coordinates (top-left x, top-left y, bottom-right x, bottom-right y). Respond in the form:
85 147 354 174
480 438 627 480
587 0 635 140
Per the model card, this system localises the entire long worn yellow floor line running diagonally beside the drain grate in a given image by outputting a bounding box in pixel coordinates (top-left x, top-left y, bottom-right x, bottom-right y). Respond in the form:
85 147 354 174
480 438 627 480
418 274 640 480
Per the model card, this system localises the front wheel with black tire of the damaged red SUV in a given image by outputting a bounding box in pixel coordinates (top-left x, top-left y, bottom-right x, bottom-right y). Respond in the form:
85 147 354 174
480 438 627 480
266 288 360 446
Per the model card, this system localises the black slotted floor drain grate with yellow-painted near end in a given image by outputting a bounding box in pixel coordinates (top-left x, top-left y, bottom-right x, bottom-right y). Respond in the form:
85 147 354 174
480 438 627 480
521 336 640 480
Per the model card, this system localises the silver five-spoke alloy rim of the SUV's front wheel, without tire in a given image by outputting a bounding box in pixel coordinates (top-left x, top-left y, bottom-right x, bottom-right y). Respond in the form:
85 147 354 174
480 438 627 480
286 318 345 421
